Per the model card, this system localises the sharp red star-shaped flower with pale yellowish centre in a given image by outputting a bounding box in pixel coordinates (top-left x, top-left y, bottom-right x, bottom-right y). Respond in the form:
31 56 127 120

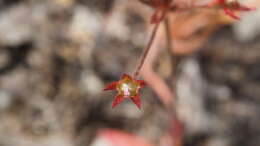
104 74 146 109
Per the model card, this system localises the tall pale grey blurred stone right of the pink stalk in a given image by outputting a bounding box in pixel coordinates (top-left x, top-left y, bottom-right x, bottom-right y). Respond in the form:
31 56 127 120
176 59 212 133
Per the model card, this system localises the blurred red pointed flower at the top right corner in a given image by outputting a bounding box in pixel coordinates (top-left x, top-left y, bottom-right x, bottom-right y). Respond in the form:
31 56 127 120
210 0 255 19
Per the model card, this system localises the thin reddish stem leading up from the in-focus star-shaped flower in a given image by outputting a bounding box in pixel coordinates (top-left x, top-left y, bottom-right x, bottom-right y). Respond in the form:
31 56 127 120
134 22 160 78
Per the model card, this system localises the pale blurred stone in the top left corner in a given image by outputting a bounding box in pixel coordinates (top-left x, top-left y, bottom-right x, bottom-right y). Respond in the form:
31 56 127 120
0 5 33 46
